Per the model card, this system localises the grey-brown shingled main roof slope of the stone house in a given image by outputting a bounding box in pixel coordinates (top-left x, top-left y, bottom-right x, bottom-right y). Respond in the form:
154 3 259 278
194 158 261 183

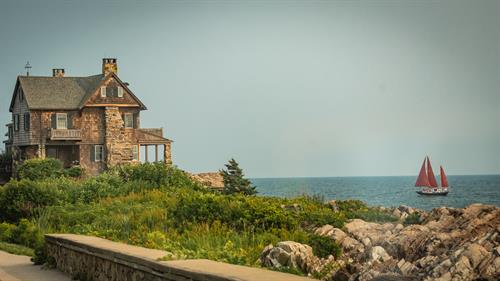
11 74 104 110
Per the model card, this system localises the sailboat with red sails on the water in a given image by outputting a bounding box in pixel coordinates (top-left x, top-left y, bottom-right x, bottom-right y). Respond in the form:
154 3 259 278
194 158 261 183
415 156 449 195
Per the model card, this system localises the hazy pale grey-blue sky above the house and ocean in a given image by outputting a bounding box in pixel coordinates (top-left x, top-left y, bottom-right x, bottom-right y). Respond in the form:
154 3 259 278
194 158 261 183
0 0 500 177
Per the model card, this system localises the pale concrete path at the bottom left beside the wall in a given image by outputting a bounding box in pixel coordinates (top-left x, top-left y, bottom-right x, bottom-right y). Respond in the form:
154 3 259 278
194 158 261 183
0 251 71 281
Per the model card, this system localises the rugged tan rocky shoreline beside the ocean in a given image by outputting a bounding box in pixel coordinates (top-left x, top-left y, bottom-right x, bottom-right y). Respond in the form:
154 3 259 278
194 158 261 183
261 204 500 281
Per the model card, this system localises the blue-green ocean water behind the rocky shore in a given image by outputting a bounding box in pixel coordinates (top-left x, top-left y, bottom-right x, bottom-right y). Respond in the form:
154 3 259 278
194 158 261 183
251 175 500 210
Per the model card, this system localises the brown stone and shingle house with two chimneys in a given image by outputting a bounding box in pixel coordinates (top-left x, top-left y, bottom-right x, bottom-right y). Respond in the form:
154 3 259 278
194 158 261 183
4 58 172 174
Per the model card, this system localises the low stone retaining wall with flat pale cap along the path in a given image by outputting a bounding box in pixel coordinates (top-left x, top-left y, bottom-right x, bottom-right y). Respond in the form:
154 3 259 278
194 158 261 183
45 234 311 281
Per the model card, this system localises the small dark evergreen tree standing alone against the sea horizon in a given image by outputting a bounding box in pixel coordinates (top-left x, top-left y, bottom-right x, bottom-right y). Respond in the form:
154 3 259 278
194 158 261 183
220 158 257 195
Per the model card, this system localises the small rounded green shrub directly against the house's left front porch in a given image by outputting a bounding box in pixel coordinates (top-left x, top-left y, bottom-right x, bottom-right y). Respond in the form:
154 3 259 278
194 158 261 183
17 158 63 180
